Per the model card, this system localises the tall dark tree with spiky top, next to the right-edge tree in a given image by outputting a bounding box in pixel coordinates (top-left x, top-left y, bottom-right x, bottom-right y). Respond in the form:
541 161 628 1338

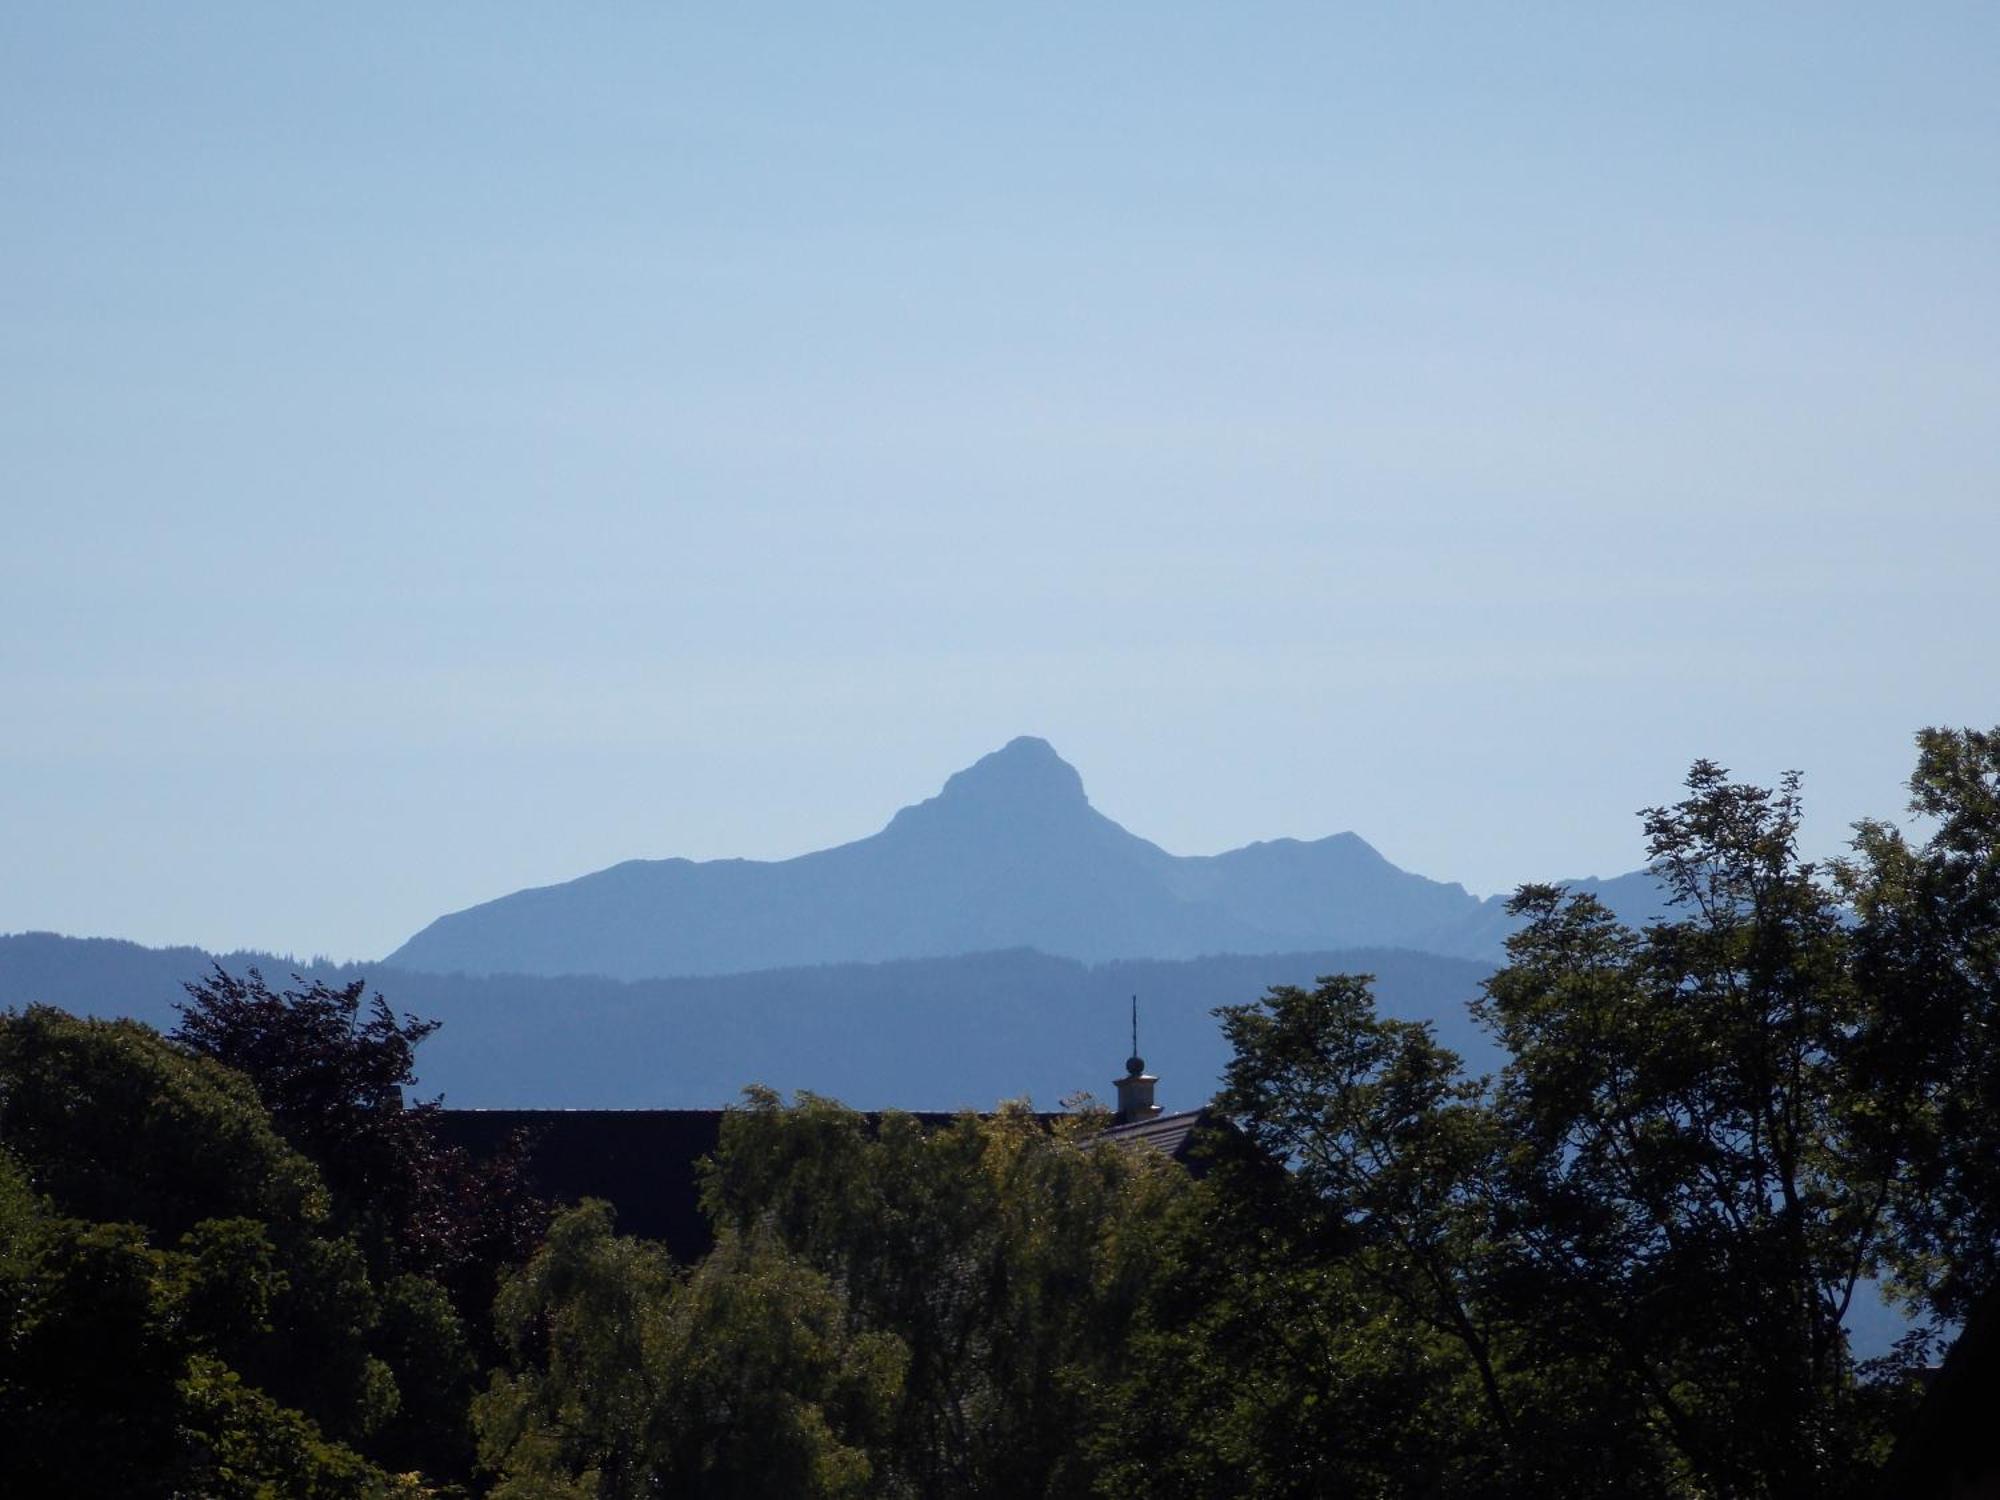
1482 762 1920 1496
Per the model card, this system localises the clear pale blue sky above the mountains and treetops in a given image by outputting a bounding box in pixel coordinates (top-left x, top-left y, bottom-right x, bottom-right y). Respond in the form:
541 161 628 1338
0 0 2000 958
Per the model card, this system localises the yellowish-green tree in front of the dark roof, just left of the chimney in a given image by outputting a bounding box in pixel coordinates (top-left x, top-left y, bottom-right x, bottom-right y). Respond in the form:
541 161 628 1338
706 1090 1186 1496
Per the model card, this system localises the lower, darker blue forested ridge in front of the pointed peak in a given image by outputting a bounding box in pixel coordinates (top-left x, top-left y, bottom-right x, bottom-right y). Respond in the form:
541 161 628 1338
0 932 1494 1110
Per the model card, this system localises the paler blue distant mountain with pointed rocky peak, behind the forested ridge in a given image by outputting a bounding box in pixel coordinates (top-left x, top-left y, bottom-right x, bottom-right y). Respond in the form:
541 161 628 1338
384 738 1664 978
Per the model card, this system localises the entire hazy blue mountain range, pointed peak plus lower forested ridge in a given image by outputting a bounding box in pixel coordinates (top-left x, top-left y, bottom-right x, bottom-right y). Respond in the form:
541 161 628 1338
0 738 1660 1108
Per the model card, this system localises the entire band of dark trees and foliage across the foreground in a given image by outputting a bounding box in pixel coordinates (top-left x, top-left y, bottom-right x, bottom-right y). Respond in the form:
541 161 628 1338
15 730 2000 1500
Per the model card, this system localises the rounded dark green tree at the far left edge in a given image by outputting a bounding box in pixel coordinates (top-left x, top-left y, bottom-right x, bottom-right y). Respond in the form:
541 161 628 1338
0 1008 450 1494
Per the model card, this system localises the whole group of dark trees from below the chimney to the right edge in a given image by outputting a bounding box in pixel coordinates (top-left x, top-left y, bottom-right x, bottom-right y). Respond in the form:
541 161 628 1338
1092 748 2000 1496
